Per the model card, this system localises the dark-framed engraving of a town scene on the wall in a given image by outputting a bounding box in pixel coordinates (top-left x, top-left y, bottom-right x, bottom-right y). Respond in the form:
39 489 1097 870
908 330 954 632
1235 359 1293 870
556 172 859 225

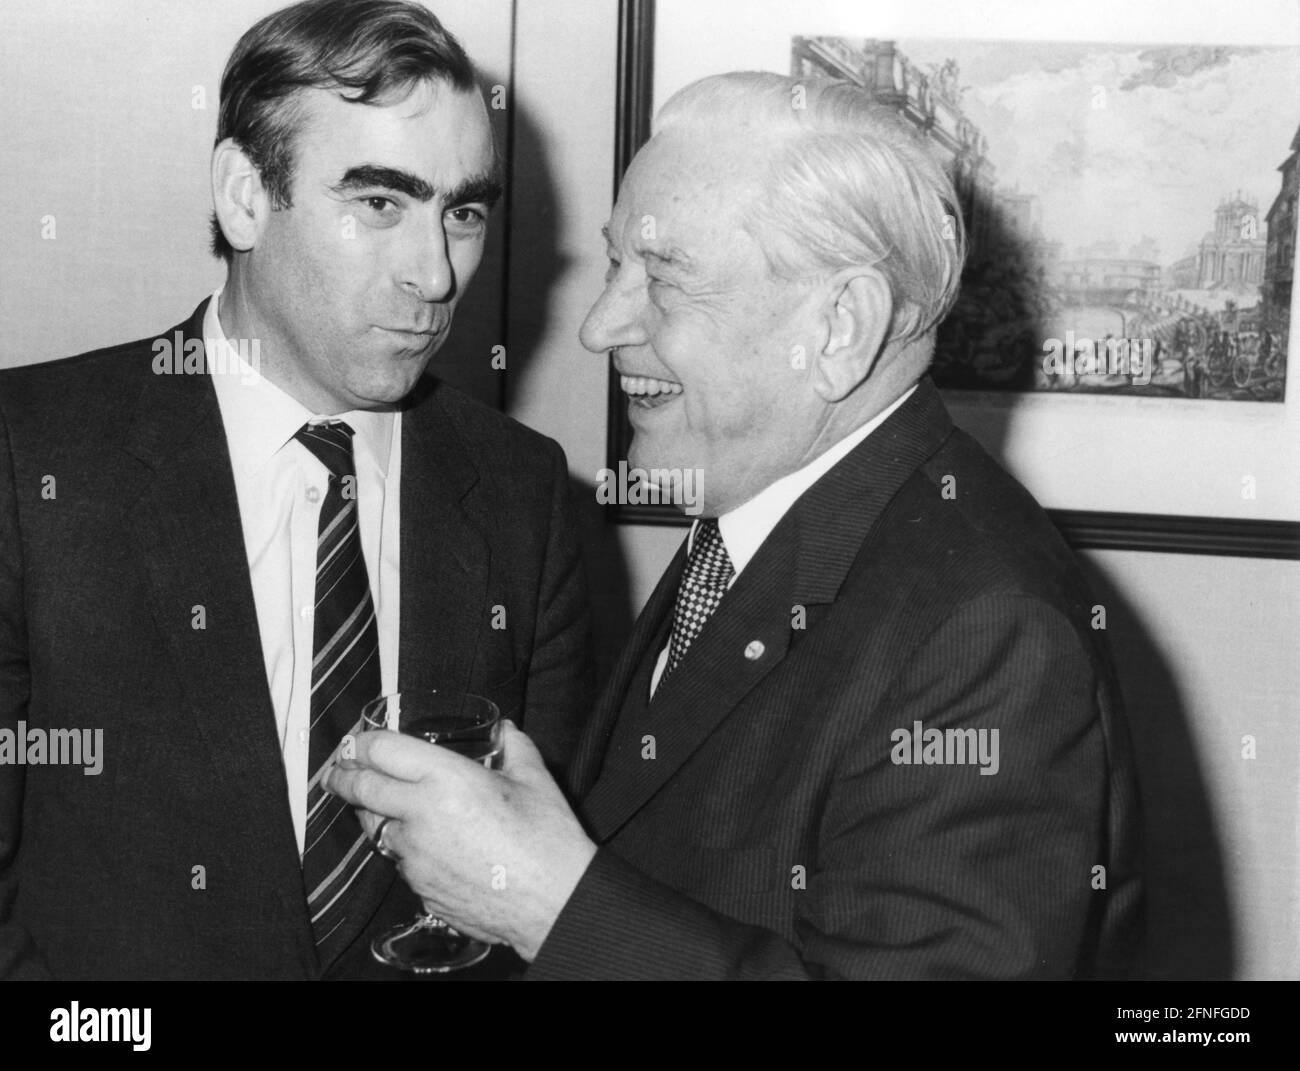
608 0 1300 559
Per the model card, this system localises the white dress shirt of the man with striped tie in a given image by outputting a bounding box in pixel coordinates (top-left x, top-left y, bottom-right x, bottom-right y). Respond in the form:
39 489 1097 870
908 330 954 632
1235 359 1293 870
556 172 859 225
203 289 402 855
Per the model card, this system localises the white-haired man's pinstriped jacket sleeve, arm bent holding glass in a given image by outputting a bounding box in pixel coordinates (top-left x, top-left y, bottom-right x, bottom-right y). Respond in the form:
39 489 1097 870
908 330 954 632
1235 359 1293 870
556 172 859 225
528 595 1106 980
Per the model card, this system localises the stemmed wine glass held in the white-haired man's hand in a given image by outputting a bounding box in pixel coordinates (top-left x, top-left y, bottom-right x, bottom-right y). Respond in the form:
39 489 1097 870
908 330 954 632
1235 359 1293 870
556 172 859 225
361 689 502 975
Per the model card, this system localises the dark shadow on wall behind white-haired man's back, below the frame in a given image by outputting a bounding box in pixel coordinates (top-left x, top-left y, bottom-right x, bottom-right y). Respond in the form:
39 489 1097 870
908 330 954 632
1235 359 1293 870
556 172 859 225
1080 559 1235 980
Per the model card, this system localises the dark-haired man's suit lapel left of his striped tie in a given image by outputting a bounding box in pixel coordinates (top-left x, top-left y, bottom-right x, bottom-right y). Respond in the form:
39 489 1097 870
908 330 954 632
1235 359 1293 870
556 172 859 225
124 303 312 958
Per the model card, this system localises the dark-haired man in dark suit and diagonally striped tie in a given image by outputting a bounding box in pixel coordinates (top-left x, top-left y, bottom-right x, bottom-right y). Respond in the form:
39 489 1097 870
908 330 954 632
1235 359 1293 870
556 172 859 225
0 0 589 979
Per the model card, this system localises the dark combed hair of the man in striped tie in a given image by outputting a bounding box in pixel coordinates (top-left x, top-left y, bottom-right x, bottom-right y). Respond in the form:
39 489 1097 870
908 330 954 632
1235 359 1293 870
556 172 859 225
212 0 476 263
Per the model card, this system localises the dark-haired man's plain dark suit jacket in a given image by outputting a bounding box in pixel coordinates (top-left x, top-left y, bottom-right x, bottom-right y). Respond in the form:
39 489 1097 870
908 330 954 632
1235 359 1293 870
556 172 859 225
0 303 590 979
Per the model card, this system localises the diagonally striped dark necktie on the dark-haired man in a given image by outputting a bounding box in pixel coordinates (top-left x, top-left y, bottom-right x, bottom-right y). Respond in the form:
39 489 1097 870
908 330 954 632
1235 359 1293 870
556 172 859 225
295 421 382 963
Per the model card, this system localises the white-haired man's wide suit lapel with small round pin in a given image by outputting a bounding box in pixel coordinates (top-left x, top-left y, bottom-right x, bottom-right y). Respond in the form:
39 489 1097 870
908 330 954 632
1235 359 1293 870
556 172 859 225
581 378 952 841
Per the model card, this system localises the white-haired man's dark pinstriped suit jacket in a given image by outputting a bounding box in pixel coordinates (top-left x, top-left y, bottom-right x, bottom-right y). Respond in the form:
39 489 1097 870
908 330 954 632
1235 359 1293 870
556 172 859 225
528 380 1139 979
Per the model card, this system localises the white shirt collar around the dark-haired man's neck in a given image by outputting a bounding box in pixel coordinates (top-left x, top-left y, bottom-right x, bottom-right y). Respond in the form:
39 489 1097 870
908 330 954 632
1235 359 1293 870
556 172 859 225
203 287 394 478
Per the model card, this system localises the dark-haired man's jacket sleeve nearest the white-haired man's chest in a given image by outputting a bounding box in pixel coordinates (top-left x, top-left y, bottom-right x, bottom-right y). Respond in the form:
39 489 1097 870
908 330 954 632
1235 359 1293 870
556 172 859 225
520 443 594 775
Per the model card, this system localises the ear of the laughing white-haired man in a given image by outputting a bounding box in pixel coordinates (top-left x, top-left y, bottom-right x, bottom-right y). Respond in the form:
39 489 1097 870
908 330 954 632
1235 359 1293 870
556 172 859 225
813 268 893 402
